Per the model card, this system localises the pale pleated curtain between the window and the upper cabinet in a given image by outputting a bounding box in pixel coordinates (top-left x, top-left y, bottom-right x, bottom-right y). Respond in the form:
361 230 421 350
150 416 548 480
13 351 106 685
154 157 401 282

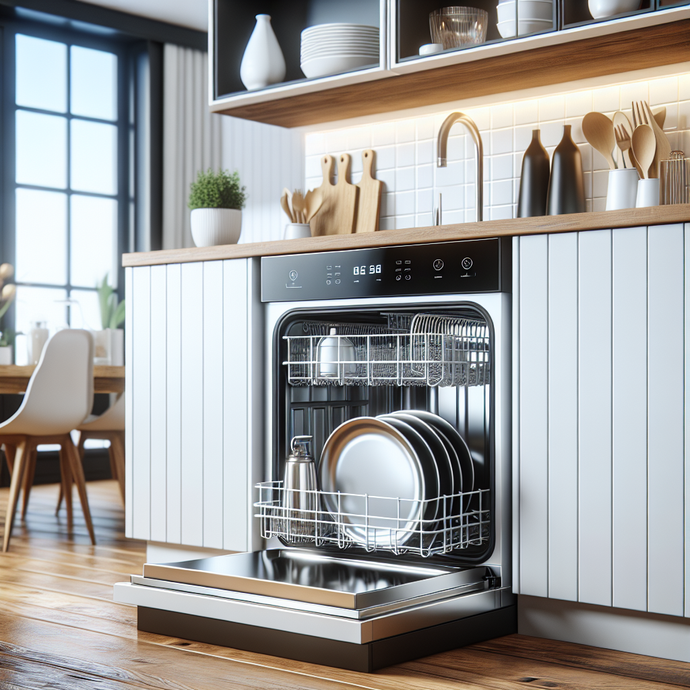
163 43 222 249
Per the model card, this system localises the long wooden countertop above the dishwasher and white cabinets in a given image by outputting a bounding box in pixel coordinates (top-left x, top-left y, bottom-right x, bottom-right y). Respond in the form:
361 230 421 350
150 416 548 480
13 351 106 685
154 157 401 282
122 204 690 266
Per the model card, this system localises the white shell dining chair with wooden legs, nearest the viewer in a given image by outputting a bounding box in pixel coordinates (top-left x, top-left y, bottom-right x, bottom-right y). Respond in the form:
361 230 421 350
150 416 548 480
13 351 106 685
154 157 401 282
0 329 96 551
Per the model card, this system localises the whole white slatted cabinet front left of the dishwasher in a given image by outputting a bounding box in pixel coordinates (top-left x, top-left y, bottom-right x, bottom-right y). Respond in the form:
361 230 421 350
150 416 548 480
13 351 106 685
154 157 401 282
125 259 264 551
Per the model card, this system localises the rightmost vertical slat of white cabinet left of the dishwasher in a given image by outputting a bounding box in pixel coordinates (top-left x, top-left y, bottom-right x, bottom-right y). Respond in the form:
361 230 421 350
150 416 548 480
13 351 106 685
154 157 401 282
223 259 250 551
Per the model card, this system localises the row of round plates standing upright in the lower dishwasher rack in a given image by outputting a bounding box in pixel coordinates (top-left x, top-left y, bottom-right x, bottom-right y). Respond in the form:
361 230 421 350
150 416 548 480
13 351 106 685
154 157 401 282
319 410 474 549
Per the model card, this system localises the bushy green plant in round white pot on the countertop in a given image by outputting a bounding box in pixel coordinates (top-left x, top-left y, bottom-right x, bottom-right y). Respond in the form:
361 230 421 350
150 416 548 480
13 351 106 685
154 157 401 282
187 168 247 247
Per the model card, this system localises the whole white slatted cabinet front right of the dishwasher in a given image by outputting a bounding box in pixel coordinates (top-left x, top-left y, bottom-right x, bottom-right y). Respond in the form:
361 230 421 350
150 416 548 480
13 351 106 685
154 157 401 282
513 224 690 617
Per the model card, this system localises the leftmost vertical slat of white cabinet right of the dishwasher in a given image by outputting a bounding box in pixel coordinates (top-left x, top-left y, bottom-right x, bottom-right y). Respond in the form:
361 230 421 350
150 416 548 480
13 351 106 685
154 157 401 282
519 235 548 597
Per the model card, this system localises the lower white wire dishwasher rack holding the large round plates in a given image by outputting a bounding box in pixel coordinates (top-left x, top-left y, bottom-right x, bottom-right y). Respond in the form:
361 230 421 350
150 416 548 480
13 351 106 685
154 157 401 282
254 481 490 558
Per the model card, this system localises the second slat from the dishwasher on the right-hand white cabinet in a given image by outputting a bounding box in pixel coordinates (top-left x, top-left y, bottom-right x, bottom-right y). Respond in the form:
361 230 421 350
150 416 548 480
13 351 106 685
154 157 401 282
548 233 578 601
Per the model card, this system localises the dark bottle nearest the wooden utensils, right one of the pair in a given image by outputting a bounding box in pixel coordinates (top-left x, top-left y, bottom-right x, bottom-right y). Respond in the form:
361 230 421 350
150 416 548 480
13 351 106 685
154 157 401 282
546 125 585 216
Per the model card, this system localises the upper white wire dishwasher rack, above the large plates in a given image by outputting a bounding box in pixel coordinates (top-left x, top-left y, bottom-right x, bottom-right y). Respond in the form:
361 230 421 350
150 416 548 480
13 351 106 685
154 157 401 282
283 314 491 386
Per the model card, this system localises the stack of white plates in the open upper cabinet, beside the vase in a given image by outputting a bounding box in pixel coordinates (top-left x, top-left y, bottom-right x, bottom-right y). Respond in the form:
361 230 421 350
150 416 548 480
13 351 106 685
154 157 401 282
300 24 379 79
